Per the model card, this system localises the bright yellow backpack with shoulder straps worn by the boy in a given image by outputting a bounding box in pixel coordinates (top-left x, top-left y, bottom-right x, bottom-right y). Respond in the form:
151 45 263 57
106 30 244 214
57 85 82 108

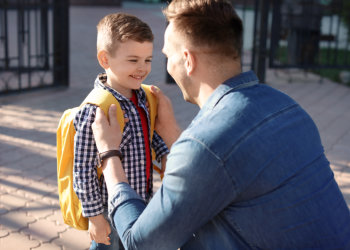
56 84 159 230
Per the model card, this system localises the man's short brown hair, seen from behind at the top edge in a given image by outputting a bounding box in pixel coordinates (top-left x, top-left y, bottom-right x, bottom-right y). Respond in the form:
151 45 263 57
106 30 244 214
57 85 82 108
163 0 243 58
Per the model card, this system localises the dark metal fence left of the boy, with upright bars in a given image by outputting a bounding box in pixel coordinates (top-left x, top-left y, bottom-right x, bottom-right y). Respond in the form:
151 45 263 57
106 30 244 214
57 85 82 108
0 0 69 94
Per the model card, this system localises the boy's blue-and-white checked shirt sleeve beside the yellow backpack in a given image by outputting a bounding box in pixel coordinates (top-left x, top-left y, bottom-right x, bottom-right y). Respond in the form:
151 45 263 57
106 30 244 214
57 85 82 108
73 104 104 217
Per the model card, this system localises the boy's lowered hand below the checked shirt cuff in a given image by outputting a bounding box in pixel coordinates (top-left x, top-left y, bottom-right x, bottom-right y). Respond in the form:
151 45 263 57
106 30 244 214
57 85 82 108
89 214 111 245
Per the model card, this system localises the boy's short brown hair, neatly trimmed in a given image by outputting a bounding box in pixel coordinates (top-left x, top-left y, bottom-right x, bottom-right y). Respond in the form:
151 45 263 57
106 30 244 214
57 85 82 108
97 13 154 55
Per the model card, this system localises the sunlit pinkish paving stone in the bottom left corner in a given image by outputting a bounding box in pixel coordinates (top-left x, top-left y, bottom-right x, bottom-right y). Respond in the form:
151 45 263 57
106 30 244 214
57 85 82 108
0 233 40 250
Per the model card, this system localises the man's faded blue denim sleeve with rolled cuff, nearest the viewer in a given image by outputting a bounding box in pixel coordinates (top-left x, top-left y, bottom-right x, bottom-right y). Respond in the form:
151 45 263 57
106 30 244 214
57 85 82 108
109 137 235 250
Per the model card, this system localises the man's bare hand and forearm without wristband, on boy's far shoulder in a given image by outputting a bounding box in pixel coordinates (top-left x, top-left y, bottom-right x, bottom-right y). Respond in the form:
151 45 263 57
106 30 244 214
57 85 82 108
151 86 181 148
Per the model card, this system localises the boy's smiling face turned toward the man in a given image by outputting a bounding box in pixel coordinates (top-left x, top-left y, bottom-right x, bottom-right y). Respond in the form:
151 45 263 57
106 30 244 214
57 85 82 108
106 40 153 97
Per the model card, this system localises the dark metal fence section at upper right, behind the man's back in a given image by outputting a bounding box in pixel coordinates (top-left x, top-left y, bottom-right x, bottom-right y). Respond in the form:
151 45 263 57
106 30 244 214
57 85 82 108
269 0 350 69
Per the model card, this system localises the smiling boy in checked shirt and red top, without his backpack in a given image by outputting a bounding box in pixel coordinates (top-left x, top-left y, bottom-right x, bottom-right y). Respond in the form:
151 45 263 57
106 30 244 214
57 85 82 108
74 13 168 249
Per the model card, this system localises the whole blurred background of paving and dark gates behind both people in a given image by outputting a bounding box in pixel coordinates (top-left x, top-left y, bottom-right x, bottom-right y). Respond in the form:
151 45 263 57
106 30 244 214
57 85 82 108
0 0 350 250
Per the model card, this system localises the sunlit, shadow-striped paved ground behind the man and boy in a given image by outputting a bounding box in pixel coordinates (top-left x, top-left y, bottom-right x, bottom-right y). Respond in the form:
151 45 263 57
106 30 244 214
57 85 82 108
0 3 350 250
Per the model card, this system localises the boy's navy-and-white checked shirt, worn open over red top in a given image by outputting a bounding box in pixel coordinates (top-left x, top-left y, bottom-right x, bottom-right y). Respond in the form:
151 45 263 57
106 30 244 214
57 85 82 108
74 74 169 217
